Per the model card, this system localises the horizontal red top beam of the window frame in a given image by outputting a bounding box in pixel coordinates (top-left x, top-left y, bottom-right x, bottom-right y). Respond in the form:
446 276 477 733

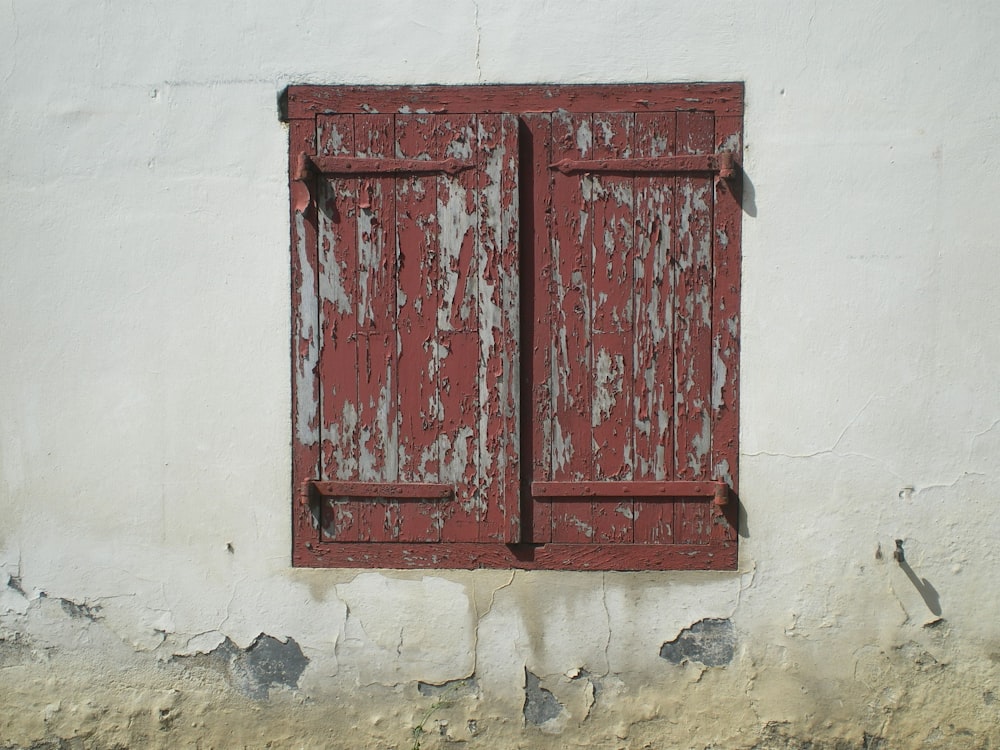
286 82 743 120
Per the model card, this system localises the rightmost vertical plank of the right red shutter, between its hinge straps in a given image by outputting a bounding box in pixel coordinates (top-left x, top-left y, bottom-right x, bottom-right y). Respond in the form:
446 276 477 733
674 112 715 544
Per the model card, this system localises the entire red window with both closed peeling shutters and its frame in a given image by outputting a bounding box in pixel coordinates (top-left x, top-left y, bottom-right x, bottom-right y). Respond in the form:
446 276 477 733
288 84 742 570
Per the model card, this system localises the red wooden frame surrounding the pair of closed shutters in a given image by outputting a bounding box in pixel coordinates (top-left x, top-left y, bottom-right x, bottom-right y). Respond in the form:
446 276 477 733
283 83 743 570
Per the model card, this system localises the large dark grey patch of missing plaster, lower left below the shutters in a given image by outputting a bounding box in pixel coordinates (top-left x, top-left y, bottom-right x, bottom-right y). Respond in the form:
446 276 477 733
176 633 309 700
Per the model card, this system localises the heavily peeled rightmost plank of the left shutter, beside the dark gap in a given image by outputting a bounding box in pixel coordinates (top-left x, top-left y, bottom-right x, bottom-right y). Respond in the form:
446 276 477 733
476 115 530 543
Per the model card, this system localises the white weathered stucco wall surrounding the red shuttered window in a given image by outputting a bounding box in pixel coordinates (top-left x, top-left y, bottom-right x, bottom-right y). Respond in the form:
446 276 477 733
0 0 1000 748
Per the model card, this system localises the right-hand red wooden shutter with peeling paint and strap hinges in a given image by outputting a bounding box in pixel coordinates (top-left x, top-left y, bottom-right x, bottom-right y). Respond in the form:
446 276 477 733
526 111 736 545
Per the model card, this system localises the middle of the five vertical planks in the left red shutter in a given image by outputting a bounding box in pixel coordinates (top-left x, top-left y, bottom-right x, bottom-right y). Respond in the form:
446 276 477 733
393 115 441 541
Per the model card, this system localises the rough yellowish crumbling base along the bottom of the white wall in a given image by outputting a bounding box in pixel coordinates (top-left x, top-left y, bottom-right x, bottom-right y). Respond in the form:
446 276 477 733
0 580 1000 750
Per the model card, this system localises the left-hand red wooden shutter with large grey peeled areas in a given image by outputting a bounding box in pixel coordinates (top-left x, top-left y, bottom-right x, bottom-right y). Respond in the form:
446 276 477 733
302 114 519 543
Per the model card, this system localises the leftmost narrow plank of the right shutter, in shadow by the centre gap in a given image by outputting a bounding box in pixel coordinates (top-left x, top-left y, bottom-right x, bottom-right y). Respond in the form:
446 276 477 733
519 114 554 543
